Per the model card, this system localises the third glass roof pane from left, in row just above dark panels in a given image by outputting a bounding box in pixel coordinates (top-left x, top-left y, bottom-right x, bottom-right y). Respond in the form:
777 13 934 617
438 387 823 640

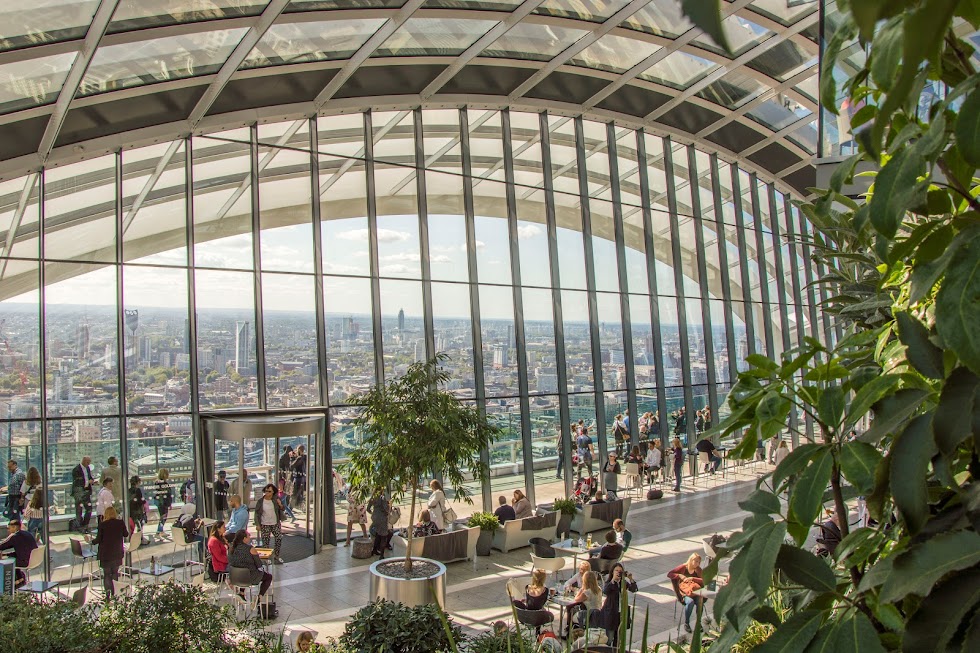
241 18 385 68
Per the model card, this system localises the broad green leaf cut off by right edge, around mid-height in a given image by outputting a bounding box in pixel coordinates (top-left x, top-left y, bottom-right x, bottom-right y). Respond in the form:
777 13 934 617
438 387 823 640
936 233 980 374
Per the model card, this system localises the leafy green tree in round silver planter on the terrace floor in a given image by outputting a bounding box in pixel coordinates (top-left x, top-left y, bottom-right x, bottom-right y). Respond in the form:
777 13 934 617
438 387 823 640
348 354 499 605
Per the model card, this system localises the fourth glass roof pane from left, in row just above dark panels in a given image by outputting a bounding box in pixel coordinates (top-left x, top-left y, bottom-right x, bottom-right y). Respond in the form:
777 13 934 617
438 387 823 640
372 18 497 57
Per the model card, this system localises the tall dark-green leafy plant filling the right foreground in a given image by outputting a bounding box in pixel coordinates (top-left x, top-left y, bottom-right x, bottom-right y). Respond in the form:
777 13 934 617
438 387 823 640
680 0 980 653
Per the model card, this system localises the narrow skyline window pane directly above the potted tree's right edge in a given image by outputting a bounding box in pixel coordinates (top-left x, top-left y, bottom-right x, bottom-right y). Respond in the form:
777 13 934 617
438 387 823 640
480 286 520 397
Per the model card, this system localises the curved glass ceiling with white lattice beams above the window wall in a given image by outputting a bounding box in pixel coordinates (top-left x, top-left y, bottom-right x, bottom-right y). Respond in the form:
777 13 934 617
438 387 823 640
0 0 819 192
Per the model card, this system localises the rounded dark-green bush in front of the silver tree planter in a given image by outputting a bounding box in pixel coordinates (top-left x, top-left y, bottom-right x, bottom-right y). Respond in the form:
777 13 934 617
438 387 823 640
339 599 463 653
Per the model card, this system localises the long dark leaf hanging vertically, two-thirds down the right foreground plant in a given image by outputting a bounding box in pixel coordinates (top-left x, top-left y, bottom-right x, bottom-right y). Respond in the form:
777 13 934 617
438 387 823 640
888 414 936 534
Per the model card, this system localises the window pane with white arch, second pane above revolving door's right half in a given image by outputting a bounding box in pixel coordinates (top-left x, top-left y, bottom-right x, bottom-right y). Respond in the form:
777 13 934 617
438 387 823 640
259 147 313 272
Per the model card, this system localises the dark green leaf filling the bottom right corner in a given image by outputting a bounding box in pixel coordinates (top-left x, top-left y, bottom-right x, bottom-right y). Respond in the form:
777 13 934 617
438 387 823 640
902 569 980 651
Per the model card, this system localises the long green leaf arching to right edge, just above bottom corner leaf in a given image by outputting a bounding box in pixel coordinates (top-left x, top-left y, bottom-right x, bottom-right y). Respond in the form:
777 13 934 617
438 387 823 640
876 530 980 603
